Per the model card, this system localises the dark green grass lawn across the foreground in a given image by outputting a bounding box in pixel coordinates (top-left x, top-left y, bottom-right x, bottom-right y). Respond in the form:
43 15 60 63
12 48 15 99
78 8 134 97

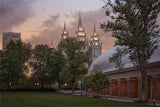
0 92 154 107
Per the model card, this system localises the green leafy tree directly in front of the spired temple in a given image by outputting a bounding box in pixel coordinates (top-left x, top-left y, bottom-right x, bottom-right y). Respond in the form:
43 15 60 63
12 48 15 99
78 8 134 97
59 38 89 94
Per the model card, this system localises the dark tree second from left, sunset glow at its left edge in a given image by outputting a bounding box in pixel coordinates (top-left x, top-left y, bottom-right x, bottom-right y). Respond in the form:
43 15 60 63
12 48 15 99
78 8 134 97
30 45 53 88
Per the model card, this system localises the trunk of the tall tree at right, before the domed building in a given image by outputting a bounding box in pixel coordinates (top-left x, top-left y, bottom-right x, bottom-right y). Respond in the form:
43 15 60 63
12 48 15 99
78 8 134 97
138 52 148 103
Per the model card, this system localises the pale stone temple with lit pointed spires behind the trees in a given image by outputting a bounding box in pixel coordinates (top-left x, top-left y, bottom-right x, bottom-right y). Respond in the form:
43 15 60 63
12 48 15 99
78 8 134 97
59 14 102 66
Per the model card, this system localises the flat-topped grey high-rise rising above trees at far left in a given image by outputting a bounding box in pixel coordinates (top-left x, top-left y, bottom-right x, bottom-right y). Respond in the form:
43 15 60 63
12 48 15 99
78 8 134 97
2 32 21 50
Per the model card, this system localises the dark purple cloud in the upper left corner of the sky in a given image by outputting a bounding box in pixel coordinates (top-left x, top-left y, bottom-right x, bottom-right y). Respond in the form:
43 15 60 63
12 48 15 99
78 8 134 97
0 0 34 49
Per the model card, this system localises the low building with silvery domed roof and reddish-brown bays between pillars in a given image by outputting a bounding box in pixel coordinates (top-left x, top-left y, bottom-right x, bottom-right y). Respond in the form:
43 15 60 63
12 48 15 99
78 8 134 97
87 39 160 100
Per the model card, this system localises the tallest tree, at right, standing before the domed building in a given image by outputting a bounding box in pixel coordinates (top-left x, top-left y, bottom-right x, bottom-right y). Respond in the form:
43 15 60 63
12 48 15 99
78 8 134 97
101 0 160 102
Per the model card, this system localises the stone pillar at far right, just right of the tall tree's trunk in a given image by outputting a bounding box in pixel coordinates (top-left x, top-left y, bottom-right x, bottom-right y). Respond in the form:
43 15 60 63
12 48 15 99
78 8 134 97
151 75 157 99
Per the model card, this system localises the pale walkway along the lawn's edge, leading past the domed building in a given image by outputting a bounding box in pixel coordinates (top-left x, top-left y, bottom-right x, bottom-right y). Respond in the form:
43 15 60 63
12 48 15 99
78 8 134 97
57 90 160 106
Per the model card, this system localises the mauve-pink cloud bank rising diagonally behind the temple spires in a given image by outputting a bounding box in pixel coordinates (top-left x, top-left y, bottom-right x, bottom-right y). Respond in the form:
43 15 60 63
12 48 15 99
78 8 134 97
27 8 114 51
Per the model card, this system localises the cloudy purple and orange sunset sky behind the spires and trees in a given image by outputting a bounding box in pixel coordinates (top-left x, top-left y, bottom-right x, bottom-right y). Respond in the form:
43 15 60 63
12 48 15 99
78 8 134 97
0 0 114 52
